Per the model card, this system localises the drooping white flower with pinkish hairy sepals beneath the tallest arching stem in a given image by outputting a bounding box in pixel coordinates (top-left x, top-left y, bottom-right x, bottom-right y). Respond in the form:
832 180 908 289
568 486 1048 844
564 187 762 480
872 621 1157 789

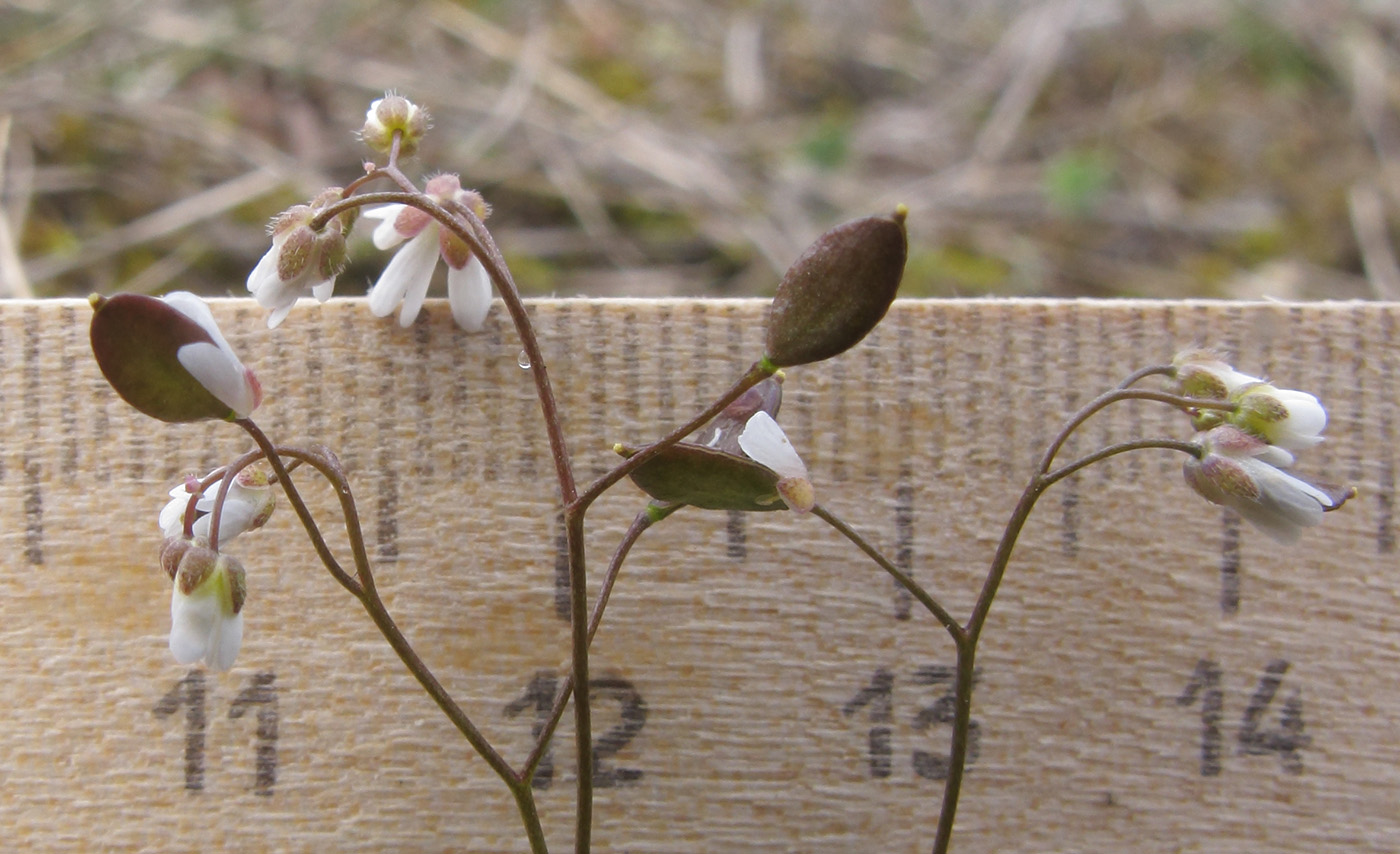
364 175 491 332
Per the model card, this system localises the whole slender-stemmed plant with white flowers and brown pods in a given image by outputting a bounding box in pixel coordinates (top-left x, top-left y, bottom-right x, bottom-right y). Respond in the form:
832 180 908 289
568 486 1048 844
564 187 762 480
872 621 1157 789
91 95 1351 854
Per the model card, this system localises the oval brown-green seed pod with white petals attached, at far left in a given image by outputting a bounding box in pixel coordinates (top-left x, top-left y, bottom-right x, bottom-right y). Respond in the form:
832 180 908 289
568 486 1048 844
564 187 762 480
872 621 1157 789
90 291 262 423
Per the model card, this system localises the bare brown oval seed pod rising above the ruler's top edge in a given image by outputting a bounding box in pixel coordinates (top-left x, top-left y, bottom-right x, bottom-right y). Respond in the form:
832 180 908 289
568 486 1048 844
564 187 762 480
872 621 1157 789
766 206 909 367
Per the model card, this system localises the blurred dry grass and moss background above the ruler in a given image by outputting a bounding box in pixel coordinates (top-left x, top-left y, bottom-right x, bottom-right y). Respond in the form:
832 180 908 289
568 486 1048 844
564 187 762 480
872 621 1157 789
0 0 1400 300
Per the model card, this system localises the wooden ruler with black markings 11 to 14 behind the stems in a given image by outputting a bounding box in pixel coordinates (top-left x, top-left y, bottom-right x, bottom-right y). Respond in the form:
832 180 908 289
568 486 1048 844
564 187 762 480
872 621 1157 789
0 295 1400 853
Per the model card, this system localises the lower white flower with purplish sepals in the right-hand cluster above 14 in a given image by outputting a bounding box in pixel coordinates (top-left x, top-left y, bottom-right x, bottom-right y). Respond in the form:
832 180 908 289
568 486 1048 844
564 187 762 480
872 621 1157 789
1183 424 1345 543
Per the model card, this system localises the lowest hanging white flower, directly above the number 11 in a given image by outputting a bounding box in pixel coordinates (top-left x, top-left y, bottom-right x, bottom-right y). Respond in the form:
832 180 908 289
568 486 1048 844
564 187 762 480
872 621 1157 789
169 547 246 671
